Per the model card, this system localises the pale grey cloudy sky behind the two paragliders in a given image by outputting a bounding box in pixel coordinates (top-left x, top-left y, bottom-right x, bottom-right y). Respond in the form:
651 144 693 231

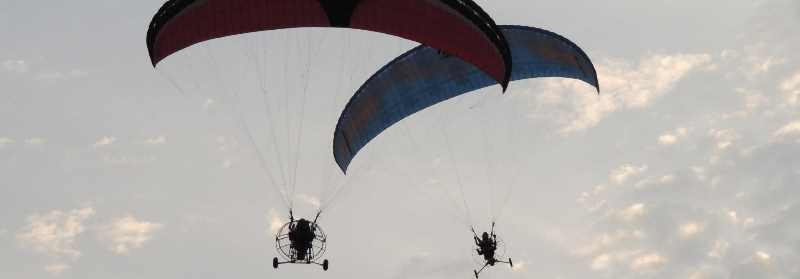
0 0 800 279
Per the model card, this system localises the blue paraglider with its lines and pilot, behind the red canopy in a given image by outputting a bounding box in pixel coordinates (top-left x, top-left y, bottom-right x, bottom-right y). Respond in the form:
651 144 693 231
333 26 600 278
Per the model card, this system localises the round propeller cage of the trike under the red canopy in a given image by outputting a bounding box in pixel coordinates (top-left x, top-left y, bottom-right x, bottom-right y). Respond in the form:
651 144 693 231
275 220 328 263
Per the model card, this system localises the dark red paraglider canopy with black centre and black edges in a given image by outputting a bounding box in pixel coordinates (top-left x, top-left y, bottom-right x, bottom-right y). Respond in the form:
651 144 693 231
147 0 511 88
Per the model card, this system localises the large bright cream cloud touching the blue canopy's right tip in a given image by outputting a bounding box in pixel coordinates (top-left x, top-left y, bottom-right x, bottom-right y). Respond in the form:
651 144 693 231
530 54 712 134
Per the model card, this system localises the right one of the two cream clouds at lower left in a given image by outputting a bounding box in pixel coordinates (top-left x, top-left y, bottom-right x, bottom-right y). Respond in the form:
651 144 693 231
100 215 164 255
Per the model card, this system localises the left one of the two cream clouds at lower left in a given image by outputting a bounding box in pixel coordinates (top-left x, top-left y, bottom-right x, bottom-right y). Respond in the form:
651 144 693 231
17 207 95 259
